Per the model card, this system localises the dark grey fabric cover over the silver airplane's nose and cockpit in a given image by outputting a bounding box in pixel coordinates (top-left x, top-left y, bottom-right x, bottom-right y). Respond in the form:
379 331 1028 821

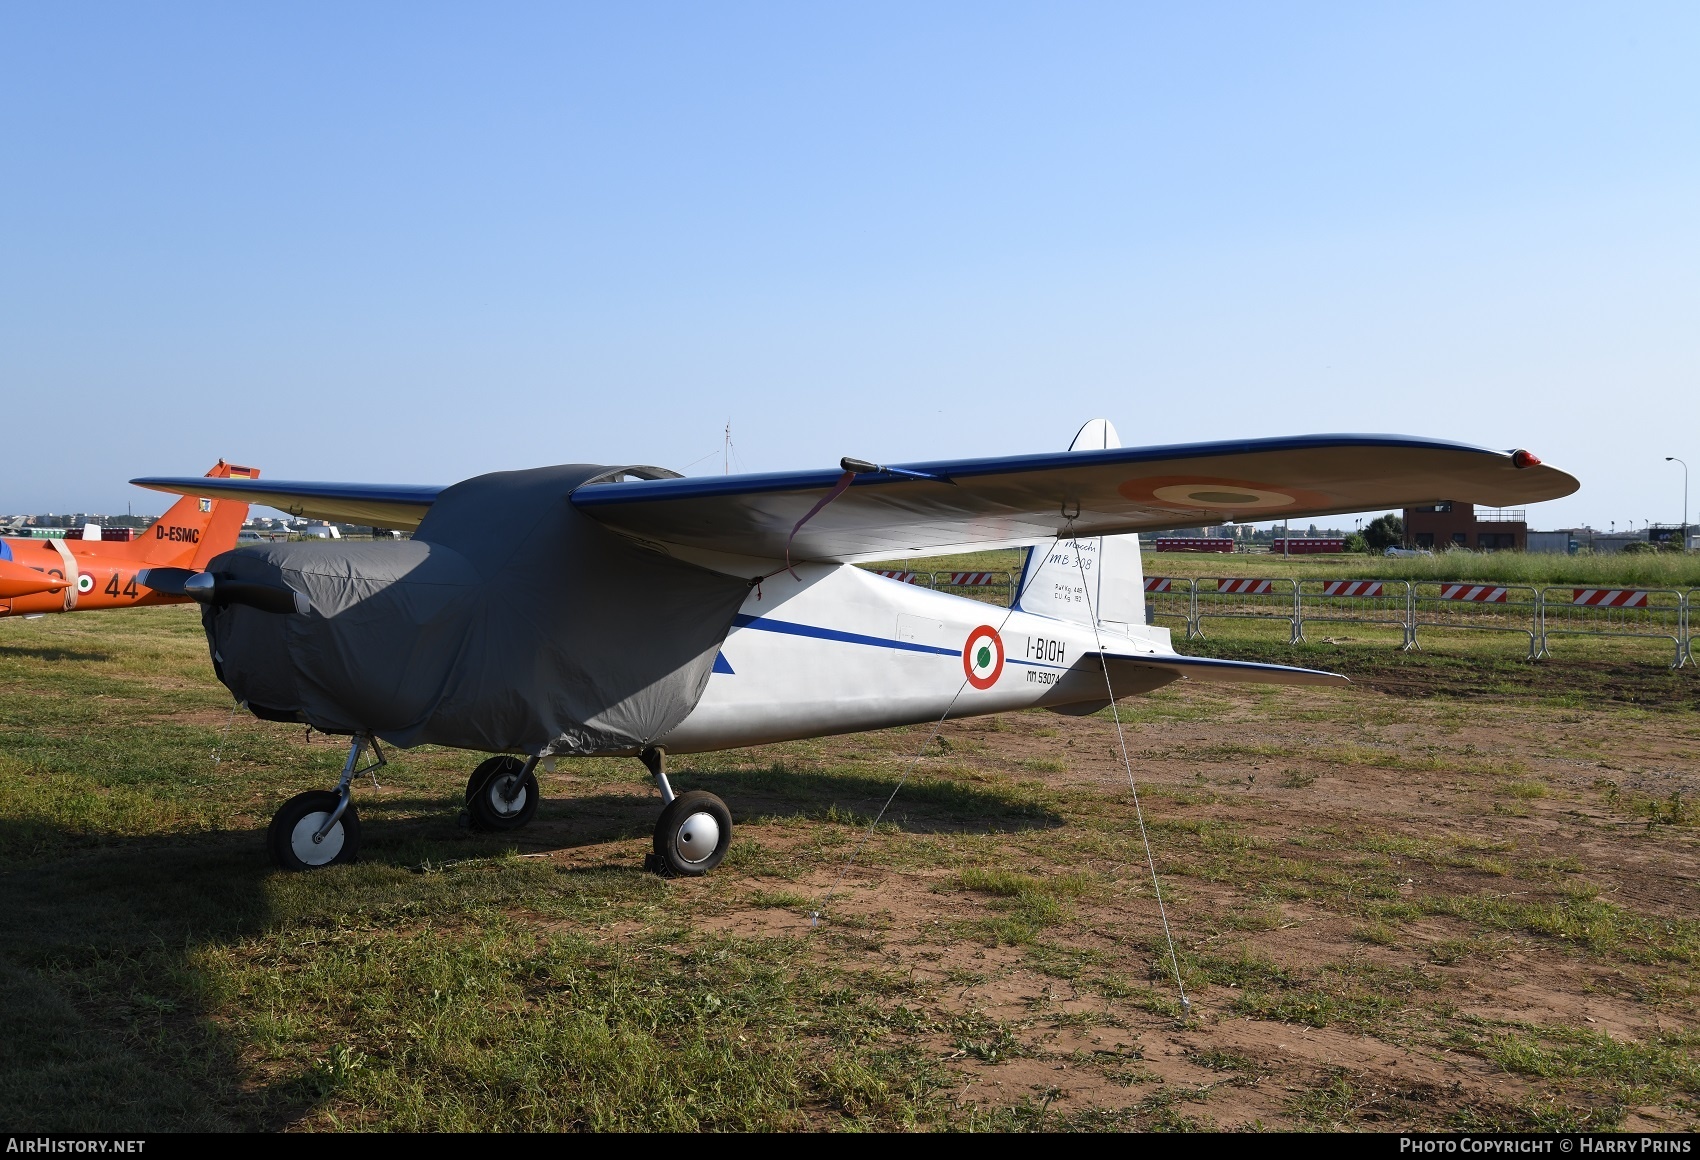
202 464 750 755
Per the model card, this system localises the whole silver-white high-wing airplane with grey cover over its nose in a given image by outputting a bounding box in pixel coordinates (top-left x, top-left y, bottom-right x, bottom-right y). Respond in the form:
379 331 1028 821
134 420 1578 874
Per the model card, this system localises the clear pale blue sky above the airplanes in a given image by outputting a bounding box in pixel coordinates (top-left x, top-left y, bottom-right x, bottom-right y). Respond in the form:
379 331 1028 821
0 2 1700 527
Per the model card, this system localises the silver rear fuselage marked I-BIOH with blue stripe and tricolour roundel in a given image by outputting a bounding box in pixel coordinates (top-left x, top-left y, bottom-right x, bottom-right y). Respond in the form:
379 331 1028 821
658 565 1173 753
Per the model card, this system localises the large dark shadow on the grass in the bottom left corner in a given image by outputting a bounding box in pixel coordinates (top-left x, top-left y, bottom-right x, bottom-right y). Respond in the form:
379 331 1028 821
0 822 309 1133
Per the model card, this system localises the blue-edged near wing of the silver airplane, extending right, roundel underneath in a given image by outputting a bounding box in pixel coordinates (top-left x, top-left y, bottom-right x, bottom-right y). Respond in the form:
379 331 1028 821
573 435 1579 563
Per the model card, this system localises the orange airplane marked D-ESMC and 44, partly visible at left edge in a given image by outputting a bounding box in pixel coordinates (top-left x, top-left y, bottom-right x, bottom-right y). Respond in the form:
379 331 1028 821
0 459 260 617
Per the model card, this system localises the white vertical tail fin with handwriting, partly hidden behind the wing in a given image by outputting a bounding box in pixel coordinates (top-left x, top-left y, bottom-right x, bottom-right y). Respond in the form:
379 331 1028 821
1017 418 1146 633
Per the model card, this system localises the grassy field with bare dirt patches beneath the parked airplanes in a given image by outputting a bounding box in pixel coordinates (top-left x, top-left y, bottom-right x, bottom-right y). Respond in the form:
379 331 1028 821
0 602 1700 1131
